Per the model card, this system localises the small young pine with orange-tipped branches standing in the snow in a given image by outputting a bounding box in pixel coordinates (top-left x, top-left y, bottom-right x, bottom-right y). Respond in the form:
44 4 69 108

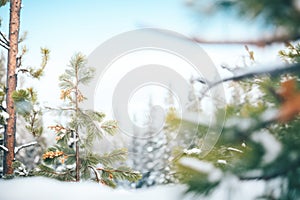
36 53 140 187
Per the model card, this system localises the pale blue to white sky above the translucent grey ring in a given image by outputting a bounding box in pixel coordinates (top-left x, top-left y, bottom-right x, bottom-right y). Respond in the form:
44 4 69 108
0 0 282 127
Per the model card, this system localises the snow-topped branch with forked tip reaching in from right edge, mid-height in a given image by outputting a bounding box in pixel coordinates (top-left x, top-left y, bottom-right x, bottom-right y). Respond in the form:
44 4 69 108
196 63 300 98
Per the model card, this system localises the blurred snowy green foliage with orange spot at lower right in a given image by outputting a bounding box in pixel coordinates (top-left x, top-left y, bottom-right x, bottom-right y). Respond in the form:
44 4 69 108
178 44 300 199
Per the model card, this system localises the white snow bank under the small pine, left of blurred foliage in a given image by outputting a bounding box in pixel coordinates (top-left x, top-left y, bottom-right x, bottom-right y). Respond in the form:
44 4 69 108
0 177 186 200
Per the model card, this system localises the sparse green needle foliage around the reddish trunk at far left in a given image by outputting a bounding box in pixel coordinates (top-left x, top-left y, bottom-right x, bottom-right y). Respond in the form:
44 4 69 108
0 48 50 176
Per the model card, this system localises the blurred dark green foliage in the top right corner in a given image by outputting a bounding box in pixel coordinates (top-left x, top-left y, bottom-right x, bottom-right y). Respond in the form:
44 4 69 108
191 0 300 38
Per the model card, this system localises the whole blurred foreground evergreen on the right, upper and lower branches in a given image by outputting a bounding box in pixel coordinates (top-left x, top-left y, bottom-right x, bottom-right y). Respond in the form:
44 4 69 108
178 0 300 199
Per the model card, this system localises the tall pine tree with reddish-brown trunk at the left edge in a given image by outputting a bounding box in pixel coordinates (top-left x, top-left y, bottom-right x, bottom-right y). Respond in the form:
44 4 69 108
0 0 49 177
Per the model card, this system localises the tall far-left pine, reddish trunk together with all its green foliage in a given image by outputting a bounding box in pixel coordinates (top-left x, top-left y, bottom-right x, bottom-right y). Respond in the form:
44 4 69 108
0 0 50 177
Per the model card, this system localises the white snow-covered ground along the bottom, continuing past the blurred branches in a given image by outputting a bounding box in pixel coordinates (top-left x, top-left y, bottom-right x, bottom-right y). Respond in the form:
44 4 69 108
0 177 264 200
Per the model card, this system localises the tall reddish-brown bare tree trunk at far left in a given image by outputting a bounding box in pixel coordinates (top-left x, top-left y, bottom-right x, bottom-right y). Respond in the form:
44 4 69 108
3 0 22 175
